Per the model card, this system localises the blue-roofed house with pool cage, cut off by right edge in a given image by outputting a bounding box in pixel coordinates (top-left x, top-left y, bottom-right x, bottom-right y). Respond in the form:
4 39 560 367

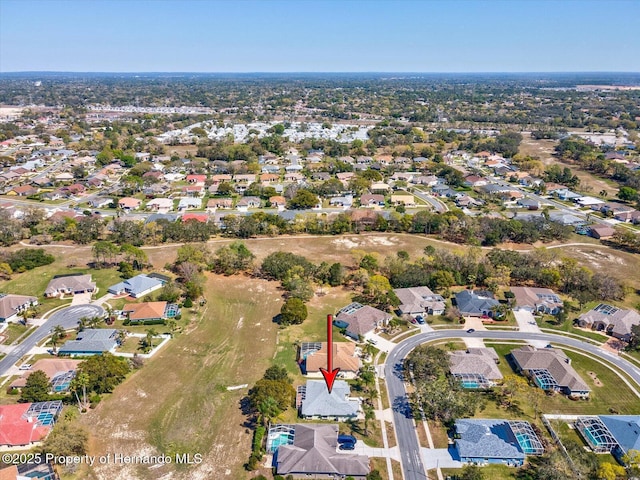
575 415 640 465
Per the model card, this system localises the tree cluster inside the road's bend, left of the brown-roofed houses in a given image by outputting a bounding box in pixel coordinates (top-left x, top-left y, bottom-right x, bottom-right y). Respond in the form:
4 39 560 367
404 345 480 424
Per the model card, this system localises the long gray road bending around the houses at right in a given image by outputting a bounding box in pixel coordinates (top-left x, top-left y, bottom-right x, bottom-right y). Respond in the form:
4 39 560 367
385 330 640 480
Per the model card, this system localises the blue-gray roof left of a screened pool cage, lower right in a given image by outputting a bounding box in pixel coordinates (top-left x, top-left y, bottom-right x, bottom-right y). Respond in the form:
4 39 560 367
456 419 525 459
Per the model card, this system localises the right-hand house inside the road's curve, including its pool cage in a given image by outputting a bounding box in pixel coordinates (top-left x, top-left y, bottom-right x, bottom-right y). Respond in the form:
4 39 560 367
511 345 591 398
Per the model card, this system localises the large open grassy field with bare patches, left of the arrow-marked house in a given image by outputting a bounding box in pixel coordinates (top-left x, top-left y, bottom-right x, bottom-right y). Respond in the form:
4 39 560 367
77 275 281 480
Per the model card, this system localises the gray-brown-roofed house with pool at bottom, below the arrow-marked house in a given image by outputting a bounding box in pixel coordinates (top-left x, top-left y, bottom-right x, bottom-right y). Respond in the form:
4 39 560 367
269 423 370 479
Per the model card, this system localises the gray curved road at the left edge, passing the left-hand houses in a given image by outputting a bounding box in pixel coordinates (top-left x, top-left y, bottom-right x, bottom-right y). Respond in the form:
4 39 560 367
0 305 105 375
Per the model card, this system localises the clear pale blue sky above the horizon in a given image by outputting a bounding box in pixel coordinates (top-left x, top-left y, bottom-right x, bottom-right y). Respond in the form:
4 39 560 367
0 0 640 73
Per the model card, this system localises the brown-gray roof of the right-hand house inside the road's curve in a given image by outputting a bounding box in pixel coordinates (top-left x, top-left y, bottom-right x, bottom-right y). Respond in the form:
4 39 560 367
511 345 591 392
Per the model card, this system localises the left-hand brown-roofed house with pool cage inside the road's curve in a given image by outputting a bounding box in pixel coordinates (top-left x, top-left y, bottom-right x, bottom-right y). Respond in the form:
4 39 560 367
449 347 502 389
